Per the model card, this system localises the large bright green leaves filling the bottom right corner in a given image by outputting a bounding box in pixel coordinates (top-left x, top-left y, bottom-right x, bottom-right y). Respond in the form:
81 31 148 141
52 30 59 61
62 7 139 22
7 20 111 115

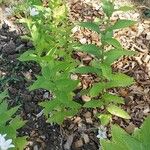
101 117 150 150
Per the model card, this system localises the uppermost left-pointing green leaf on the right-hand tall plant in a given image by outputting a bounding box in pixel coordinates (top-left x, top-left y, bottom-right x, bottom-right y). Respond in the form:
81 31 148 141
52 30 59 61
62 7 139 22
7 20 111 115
79 22 100 33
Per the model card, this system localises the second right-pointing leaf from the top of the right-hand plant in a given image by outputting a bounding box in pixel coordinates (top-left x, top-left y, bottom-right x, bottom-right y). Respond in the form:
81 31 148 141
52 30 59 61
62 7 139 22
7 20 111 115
109 19 136 30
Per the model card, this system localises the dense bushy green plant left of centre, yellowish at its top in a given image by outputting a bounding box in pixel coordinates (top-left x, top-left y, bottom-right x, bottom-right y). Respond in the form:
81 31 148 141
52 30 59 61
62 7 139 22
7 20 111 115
19 0 81 124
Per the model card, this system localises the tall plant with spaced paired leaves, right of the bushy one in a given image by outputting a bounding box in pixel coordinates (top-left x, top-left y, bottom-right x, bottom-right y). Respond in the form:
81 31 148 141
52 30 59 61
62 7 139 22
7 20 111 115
73 0 136 125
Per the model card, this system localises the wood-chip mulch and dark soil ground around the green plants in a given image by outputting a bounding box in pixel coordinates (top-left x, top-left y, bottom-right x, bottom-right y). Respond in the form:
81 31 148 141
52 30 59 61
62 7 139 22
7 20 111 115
0 0 150 150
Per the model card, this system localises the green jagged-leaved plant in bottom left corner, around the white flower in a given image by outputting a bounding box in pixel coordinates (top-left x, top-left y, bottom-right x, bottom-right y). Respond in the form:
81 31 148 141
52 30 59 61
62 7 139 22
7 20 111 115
0 91 26 150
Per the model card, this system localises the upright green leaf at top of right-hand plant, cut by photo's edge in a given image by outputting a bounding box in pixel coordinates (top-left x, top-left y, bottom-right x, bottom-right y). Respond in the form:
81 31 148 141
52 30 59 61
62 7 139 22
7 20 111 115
102 0 114 18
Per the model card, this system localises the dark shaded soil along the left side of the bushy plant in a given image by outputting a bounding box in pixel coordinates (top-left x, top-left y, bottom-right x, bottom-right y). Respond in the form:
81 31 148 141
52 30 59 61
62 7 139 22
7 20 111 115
0 24 62 150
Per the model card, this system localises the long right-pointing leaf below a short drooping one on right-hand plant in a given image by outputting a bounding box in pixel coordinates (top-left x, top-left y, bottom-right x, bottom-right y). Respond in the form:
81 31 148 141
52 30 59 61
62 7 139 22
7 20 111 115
104 49 137 65
